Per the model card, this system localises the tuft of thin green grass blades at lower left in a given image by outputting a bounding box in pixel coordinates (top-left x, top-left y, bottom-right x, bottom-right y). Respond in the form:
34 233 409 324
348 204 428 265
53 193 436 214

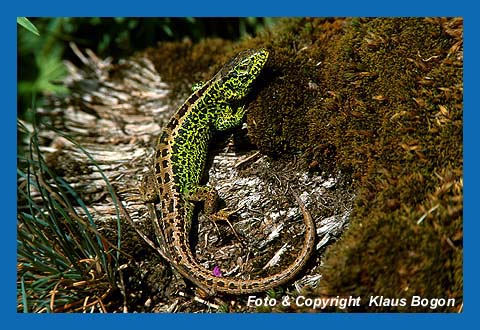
17 116 120 312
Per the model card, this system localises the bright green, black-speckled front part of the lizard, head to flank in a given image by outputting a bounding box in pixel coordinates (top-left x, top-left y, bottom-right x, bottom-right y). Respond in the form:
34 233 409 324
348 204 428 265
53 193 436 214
166 49 268 196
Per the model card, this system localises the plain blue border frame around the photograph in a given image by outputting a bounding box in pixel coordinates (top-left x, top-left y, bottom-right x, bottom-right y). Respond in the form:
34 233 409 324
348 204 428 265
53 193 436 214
5 0 474 330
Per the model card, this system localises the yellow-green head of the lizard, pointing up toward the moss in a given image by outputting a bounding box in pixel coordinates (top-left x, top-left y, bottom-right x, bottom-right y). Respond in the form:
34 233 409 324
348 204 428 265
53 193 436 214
215 48 268 101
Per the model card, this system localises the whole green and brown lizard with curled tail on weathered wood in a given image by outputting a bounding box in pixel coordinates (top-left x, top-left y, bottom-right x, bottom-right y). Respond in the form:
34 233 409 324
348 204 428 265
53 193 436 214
141 49 315 294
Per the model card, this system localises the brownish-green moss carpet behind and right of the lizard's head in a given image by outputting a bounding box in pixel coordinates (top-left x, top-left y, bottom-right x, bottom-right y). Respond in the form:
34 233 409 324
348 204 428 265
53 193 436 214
142 18 463 311
